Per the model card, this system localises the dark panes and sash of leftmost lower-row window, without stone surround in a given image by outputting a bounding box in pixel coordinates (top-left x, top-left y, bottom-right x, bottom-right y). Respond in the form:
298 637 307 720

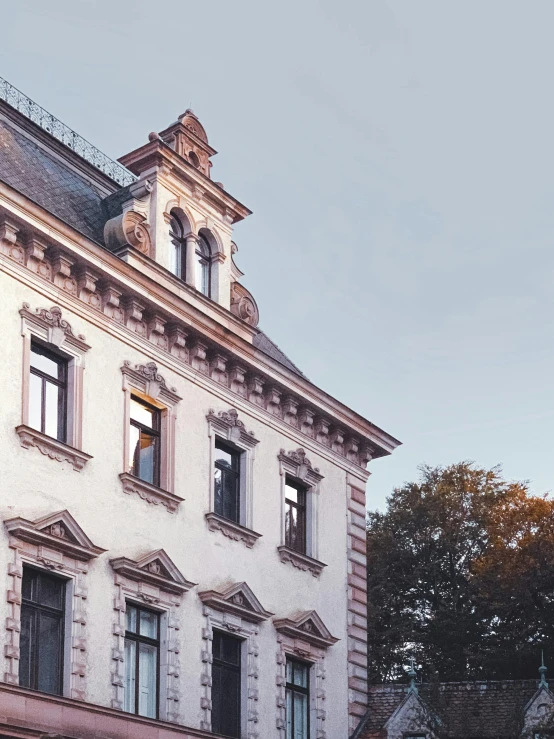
19 567 65 695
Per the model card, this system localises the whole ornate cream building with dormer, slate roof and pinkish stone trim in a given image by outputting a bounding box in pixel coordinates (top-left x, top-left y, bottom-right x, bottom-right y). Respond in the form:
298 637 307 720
0 80 399 739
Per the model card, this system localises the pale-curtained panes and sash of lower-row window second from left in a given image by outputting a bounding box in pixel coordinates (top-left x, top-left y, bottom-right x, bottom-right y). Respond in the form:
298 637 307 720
123 603 160 718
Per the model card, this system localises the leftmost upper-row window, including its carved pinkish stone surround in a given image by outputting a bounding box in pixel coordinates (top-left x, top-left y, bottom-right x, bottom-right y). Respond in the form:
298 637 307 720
16 303 90 471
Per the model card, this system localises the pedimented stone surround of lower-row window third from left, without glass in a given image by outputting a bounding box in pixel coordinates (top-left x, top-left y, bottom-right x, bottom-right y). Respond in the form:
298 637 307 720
198 582 273 739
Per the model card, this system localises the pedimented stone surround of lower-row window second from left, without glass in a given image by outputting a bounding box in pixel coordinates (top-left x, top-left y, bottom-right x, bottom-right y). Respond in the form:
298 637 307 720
110 549 196 723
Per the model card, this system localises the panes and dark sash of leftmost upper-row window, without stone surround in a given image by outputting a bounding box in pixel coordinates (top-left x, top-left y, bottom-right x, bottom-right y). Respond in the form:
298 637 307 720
29 342 67 443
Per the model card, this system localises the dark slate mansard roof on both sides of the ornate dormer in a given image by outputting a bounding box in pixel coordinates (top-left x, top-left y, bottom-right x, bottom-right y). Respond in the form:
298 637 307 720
0 119 304 377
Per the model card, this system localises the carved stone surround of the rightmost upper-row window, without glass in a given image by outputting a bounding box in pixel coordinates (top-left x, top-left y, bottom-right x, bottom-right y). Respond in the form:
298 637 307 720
277 447 327 577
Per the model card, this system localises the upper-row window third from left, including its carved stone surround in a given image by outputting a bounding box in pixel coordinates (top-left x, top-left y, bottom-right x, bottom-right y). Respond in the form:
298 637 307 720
206 408 260 547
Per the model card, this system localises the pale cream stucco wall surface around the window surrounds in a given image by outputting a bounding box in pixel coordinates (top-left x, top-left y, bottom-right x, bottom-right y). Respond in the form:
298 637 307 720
0 272 348 739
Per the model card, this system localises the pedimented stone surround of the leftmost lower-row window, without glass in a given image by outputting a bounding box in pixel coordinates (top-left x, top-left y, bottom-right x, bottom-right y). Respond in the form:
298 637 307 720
4 511 106 701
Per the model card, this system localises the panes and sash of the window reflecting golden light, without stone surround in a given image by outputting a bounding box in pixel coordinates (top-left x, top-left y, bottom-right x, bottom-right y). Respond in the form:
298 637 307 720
129 395 161 487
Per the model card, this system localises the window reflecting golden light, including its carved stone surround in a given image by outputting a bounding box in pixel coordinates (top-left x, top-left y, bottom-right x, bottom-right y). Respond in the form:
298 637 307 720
119 362 183 513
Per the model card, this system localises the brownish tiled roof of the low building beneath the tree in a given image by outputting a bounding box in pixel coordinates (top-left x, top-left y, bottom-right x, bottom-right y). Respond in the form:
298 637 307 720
353 680 538 739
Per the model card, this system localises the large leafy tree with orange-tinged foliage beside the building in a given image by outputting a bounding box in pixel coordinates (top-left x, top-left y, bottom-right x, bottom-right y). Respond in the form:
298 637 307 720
367 462 554 681
